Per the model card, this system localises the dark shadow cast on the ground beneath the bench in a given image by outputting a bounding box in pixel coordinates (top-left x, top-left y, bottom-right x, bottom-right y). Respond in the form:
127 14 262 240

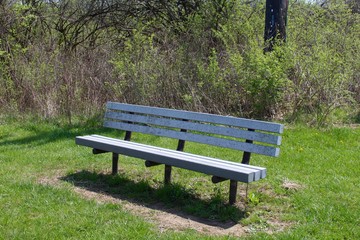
60 170 246 229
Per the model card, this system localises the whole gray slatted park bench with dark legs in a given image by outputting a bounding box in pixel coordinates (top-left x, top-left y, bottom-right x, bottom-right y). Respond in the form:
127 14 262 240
75 102 283 204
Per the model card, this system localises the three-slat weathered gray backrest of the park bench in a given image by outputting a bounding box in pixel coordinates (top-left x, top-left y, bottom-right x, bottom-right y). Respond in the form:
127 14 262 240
104 102 283 156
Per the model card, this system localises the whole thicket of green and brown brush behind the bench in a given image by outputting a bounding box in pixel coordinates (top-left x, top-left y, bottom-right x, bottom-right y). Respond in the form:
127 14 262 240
0 0 360 126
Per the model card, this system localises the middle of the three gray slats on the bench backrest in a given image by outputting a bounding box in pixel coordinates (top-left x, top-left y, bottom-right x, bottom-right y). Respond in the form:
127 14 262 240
105 111 281 145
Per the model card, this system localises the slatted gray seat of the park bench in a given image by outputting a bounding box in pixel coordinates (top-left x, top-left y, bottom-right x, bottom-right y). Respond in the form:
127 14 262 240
76 136 261 182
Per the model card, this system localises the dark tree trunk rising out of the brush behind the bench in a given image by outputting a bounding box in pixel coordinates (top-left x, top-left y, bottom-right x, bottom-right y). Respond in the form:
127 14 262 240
264 0 289 52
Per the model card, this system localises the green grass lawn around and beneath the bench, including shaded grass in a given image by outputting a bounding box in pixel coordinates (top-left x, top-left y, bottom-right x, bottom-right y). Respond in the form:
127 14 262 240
0 117 360 239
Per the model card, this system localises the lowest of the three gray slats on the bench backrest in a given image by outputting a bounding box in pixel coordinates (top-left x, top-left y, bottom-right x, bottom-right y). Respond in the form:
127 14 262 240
104 121 279 157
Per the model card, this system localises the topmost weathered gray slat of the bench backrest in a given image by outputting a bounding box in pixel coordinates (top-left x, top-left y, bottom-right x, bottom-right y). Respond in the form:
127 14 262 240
107 102 283 133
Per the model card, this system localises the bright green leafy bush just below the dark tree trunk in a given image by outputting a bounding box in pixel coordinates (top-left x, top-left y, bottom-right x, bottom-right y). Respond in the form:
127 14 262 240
243 43 290 118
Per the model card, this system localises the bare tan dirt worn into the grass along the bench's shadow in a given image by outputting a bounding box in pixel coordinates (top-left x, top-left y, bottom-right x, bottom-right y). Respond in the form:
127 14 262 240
39 172 289 237
